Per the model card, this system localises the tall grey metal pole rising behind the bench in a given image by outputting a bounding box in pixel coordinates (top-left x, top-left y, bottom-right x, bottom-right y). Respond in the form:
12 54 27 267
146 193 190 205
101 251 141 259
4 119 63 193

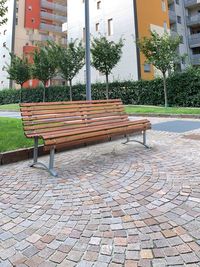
85 0 92 100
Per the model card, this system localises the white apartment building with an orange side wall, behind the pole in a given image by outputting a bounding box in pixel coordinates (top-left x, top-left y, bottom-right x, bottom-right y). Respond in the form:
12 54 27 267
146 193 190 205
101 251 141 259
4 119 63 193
67 0 169 82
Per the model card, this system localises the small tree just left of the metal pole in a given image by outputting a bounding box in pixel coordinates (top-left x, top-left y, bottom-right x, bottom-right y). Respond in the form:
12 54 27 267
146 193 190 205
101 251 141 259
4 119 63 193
59 42 85 101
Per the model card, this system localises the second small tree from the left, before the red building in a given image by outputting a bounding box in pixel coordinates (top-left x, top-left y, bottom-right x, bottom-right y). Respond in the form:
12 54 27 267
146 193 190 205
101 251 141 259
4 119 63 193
32 42 58 101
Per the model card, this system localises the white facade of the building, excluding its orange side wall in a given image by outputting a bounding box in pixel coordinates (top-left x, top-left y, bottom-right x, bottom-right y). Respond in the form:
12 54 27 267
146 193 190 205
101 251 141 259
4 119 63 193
67 0 138 83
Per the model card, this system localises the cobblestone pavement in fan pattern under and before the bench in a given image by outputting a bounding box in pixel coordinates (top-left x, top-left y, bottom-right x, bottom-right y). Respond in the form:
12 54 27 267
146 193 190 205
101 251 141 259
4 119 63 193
0 120 200 267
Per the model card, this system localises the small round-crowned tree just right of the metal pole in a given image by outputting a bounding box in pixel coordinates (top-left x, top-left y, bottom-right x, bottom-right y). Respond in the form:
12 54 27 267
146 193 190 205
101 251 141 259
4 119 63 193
91 37 124 99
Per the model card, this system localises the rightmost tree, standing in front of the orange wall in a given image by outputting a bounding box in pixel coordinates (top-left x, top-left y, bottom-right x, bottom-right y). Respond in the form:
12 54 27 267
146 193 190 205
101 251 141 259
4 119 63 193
137 32 181 107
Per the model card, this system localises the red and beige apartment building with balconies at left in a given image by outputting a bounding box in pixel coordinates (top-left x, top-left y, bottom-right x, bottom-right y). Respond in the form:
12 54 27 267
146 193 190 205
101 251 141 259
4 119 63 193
0 0 67 89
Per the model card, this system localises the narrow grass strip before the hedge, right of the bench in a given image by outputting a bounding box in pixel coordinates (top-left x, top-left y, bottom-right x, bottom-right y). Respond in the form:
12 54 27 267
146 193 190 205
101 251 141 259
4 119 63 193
126 105 200 115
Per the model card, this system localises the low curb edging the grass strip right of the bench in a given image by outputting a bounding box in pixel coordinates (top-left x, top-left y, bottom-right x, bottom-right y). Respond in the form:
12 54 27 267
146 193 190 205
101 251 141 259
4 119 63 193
128 113 200 119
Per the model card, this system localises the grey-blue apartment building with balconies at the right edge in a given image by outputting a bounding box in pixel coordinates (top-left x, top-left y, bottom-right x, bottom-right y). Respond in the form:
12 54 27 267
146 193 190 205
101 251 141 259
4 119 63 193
168 0 200 69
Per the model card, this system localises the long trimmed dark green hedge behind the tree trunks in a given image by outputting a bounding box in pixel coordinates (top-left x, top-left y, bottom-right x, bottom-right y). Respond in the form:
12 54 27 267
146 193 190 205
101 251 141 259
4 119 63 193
0 69 200 107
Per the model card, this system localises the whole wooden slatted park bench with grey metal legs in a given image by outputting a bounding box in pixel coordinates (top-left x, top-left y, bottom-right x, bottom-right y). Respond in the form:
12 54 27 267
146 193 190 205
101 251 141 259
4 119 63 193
20 99 151 176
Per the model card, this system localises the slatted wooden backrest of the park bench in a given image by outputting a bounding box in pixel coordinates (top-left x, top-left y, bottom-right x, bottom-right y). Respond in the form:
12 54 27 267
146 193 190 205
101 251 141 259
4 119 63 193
20 99 128 137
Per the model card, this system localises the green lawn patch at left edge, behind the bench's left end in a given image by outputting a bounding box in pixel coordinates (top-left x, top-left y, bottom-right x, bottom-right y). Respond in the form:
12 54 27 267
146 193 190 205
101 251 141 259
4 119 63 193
0 118 42 153
